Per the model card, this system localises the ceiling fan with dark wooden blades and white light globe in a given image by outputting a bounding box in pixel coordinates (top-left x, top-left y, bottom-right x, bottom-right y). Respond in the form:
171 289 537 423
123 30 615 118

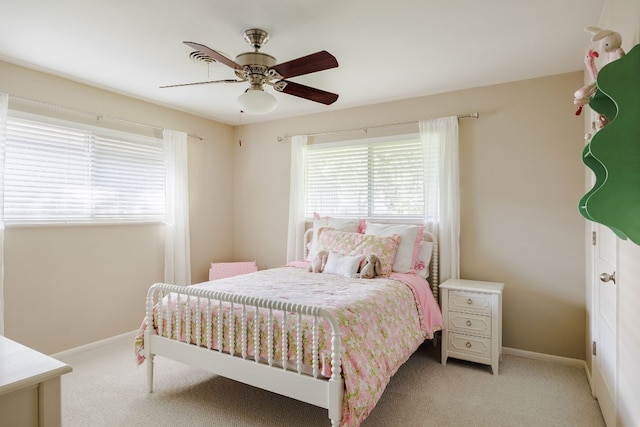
160 28 338 114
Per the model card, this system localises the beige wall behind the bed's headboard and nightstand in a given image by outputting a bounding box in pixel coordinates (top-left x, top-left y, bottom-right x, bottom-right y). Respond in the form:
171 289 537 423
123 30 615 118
233 72 585 359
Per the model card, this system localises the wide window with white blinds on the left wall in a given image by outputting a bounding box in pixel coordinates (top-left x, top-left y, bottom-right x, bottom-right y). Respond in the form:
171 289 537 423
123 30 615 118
4 112 165 224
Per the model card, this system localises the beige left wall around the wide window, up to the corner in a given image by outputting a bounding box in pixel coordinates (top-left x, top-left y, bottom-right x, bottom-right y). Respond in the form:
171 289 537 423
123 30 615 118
0 62 233 353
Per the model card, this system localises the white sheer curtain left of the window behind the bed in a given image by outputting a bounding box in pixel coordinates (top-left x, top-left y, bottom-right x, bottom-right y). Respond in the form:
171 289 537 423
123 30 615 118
287 135 307 262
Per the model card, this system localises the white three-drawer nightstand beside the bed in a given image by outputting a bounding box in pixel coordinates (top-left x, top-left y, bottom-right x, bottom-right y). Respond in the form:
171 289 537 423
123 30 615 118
440 279 504 375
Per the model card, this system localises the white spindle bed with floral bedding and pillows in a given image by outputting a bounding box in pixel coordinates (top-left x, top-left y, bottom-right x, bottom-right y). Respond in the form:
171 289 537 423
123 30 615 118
135 220 442 426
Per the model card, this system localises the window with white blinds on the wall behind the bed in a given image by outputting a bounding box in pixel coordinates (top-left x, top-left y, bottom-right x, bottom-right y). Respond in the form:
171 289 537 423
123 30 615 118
304 135 424 220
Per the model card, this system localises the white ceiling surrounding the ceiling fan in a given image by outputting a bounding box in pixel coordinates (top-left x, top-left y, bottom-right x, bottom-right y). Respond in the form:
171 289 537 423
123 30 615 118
0 0 605 124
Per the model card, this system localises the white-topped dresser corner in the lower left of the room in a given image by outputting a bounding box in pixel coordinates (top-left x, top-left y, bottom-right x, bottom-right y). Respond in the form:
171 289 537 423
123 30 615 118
0 336 71 427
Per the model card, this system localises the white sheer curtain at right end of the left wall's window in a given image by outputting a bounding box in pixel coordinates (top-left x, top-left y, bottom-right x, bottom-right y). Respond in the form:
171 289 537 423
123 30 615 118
163 129 191 285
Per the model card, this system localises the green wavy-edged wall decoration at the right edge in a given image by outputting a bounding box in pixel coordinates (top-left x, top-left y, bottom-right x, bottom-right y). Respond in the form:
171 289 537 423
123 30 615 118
578 45 640 245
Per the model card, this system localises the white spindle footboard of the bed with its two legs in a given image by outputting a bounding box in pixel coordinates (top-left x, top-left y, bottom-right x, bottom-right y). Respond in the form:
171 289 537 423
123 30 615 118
144 283 344 426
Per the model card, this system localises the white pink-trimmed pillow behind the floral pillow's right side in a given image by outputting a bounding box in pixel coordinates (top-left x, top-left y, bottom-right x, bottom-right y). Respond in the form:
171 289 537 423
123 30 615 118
365 221 424 273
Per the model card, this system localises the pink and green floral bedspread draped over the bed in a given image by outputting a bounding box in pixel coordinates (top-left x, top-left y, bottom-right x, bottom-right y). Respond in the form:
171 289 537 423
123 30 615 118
135 267 442 426
